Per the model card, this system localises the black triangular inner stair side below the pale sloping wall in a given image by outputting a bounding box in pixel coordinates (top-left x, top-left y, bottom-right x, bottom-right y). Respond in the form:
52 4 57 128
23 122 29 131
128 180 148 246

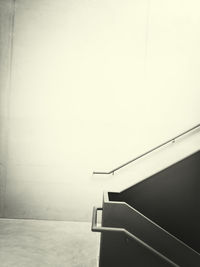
117 152 200 252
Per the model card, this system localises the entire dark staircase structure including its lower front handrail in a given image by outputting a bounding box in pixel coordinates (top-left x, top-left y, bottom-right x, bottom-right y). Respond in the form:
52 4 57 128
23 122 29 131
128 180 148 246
92 135 200 267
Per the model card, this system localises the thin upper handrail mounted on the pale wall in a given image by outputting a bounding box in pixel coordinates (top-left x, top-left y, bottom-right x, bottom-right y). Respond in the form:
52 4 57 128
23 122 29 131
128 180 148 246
93 123 200 174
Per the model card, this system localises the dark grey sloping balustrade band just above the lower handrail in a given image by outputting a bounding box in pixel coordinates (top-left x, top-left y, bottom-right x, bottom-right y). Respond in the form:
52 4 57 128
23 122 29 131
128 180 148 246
102 201 200 267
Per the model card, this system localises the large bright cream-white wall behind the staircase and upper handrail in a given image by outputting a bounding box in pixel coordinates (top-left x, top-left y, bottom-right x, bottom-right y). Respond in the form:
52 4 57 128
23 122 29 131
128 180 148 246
1 0 200 221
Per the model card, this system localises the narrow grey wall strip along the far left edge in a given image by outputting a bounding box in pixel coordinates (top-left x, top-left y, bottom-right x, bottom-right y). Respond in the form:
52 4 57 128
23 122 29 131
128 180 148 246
0 0 14 217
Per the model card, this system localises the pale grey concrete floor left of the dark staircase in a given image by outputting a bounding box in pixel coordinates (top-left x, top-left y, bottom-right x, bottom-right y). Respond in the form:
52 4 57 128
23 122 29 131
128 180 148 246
0 219 99 267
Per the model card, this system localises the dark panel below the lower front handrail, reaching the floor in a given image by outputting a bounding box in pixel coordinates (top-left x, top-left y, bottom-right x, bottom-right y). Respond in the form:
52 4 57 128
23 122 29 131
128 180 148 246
99 232 173 267
